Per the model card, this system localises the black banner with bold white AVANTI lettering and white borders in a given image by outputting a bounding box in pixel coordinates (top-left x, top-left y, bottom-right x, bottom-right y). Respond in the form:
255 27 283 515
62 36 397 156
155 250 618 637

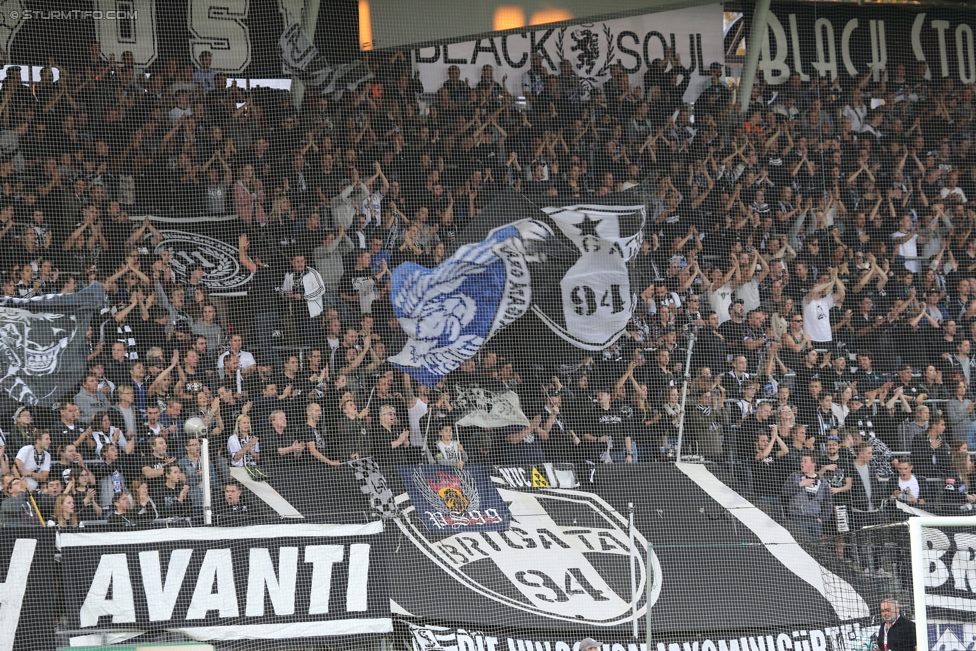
61 522 392 641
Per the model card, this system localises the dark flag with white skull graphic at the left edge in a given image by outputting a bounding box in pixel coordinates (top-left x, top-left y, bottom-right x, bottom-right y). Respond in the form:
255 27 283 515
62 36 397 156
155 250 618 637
0 283 105 407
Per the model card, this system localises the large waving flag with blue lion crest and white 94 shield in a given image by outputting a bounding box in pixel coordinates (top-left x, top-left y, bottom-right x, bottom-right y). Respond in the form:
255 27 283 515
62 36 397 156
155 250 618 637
390 195 646 386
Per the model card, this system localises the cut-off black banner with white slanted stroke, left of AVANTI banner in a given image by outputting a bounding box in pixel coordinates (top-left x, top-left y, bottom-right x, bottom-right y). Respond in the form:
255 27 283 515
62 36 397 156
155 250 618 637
0 527 58 651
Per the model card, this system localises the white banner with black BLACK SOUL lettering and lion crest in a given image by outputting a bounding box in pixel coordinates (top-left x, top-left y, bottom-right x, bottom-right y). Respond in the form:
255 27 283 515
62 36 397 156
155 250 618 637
413 4 725 102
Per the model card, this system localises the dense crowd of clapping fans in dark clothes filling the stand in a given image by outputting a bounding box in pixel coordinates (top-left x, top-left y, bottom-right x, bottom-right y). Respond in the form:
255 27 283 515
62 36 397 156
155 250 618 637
0 40 976 535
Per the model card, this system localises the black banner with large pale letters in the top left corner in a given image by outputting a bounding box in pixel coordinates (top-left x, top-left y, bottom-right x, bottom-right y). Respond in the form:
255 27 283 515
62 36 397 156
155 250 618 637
0 0 359 78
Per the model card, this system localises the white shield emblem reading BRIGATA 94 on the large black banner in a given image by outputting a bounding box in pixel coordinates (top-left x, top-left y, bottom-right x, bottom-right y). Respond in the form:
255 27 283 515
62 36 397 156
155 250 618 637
397 488 662 626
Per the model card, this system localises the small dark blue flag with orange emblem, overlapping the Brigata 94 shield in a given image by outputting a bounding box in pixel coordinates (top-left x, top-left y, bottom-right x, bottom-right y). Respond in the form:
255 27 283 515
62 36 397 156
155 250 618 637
397 466 512 534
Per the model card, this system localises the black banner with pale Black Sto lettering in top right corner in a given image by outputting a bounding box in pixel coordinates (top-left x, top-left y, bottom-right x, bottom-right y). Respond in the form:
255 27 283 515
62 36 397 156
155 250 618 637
750 3 976 88
